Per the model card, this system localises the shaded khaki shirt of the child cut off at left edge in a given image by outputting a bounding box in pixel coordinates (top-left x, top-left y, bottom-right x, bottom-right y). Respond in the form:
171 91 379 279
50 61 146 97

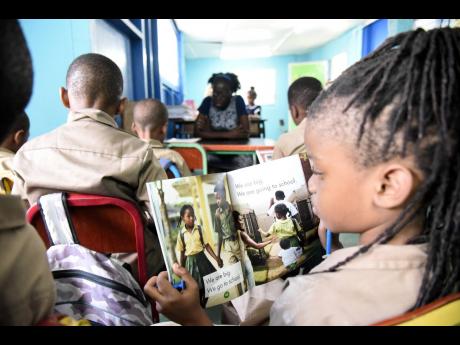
0 195 55 325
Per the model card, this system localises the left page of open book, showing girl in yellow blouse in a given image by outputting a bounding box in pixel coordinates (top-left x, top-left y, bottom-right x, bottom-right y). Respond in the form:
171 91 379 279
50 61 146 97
147 173 248 307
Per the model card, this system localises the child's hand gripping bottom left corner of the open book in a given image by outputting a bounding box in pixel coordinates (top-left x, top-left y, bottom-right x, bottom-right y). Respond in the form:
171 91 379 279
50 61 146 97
144 264 212 326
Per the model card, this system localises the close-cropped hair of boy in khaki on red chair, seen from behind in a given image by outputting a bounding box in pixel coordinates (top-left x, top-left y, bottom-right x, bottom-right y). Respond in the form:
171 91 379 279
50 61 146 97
66 53 123 106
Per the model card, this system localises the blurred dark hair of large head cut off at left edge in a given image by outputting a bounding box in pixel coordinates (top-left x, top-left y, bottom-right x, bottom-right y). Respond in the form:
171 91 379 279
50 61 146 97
0 19 33 141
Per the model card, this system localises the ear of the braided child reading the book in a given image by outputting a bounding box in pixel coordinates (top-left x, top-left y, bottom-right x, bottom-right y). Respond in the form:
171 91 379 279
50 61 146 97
373 163 416 209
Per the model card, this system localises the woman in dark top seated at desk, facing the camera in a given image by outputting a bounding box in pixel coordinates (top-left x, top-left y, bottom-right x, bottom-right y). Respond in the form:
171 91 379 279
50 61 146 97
195 73 253 172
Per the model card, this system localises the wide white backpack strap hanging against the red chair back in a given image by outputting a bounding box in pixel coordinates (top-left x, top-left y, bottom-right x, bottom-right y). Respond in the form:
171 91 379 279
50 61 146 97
38 193 79 245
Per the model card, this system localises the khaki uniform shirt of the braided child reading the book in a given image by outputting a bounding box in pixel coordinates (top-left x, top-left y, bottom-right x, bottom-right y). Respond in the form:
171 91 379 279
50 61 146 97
233 244 427 325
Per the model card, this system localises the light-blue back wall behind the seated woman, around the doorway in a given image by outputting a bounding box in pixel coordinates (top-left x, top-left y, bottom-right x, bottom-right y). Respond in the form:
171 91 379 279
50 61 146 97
184 27 362 140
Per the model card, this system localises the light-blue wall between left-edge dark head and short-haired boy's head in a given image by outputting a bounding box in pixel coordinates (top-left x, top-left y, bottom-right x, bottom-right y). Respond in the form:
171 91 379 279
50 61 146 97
20 19 91 138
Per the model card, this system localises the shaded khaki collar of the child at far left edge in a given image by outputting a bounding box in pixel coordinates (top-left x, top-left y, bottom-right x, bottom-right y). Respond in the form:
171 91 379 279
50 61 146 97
0 195 26 231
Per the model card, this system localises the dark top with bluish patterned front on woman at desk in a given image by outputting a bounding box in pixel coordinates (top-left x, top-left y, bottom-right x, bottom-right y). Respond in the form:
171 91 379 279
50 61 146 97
198 95 247 131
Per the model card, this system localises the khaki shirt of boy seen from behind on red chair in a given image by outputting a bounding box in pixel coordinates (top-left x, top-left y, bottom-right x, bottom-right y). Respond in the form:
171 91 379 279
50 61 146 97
13 109 167 275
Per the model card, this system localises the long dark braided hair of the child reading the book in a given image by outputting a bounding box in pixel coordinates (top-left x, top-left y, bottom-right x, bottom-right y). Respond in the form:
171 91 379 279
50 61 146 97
307 28 460 308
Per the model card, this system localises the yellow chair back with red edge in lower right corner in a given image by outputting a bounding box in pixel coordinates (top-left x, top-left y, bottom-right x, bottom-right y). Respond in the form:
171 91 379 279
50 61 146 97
372 292 460 326
